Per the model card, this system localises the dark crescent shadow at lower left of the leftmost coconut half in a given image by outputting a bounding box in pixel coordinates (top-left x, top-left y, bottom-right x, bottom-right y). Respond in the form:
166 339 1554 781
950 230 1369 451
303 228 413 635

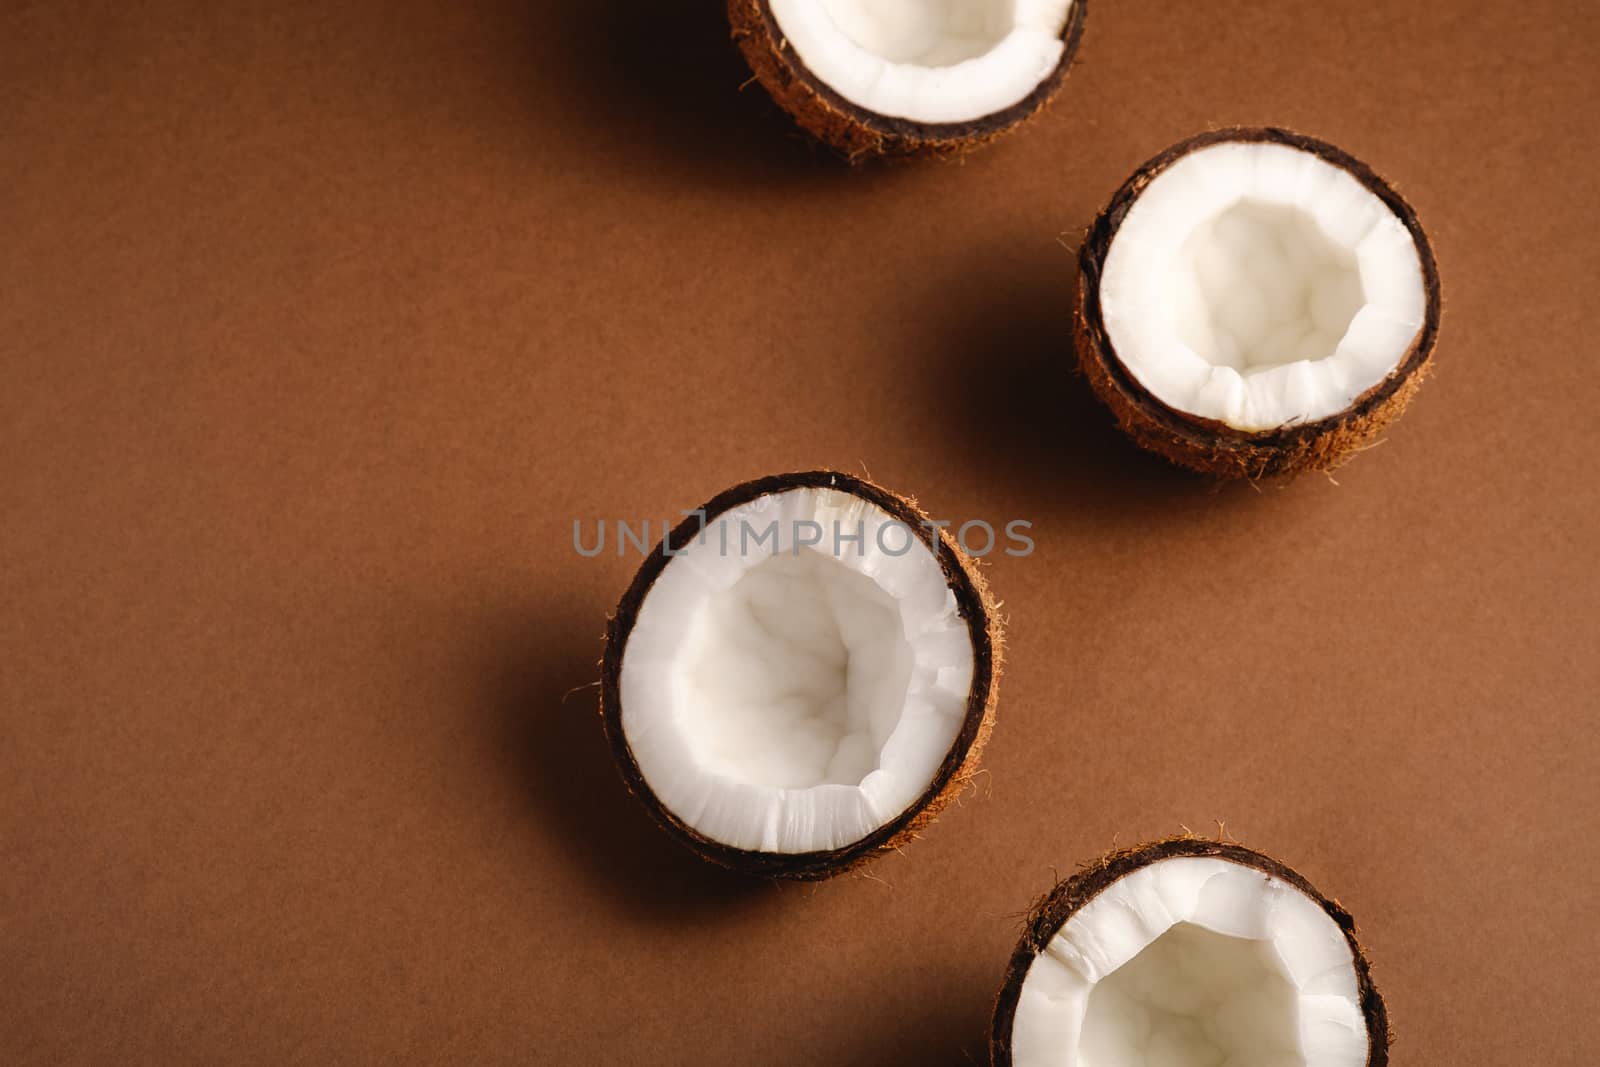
491 609 776 923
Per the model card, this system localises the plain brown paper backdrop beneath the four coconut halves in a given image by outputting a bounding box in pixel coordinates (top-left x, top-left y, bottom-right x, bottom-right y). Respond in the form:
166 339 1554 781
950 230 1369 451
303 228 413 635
0 0 1600 1067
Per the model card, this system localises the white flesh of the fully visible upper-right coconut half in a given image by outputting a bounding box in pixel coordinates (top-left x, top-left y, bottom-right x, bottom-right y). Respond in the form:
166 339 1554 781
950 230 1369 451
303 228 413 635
1099 142 1427 430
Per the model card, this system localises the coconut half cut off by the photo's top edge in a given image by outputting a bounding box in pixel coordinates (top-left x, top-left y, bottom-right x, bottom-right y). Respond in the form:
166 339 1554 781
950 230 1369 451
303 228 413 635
728 0 1088 158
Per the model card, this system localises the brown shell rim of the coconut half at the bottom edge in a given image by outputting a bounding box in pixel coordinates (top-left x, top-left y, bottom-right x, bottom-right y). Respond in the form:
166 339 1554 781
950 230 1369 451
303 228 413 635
989 837 1392 1067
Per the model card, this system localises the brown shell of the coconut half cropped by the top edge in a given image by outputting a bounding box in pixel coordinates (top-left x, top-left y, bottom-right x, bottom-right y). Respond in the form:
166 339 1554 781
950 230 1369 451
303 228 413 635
728 0 1088 162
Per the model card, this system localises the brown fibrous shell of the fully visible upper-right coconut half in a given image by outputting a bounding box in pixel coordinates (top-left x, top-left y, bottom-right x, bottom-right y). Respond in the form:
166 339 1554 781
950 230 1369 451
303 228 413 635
1074 126 1440 478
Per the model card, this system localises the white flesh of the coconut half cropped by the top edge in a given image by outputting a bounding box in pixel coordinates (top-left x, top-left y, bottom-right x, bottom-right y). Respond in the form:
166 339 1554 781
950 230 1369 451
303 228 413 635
770 0 1074 123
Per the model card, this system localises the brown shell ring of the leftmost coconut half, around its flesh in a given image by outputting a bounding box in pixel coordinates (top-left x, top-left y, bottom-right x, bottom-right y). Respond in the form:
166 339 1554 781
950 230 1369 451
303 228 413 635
600 470 1002 880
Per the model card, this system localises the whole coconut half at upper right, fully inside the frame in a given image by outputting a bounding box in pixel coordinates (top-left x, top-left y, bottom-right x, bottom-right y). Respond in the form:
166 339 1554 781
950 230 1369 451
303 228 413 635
1075 128 1440 477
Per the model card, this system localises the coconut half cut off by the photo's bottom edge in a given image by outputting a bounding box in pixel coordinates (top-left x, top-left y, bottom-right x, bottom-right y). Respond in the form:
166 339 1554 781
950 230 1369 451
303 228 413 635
990 838 1389 1067
